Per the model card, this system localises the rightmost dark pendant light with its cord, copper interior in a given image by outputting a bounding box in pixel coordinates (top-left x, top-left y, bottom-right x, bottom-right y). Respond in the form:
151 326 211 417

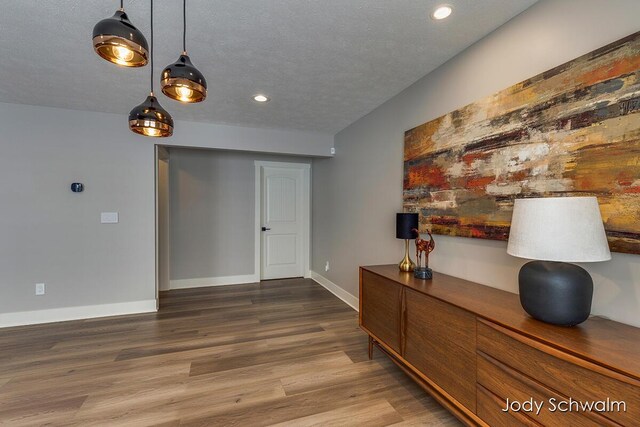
161 0 207 103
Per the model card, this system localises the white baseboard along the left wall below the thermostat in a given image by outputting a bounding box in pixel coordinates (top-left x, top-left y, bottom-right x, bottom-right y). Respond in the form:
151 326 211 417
0 299 156 328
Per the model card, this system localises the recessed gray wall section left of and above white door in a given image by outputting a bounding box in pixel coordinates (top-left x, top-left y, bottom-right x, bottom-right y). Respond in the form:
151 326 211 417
169 148 311 280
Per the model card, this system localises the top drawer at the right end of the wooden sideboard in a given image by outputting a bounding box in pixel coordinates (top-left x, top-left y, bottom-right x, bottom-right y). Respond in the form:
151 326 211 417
477 320 640 425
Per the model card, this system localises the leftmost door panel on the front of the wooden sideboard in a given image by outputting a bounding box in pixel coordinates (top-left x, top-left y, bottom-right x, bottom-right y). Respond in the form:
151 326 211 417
361 271 403 353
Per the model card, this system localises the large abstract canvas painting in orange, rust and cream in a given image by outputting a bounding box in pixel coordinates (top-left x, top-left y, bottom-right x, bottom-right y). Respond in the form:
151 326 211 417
403 32 640 254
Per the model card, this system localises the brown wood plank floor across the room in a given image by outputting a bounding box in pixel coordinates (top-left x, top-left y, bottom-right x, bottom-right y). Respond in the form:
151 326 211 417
0 279 459 426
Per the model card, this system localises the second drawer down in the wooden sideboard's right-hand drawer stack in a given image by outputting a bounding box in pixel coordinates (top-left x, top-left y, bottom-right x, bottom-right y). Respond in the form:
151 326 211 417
477 351 618 427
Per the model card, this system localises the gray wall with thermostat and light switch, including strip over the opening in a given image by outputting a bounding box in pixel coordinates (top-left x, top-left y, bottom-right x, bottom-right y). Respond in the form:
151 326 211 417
0 103 333 320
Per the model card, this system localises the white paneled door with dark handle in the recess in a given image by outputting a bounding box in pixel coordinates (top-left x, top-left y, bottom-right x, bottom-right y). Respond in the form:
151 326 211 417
260 164 309 279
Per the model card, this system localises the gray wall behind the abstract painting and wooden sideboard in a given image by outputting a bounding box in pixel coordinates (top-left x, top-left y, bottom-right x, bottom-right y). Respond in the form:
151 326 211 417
312 0 640 326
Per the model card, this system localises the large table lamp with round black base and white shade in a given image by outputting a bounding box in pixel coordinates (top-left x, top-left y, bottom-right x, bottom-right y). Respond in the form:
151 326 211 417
507 197 611 326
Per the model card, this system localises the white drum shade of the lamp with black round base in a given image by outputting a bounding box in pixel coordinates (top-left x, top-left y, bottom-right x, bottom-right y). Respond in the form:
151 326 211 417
507 197 611 262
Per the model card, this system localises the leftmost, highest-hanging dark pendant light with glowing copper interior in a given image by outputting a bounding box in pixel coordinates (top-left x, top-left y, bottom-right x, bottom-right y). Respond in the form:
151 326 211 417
93 1 148 67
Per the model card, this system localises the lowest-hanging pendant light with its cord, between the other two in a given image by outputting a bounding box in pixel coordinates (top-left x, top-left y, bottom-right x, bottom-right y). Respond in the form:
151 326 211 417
129 0 173 138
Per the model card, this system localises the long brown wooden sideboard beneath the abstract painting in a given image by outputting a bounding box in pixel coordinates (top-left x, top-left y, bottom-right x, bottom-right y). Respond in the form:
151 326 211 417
360 265 640 427
